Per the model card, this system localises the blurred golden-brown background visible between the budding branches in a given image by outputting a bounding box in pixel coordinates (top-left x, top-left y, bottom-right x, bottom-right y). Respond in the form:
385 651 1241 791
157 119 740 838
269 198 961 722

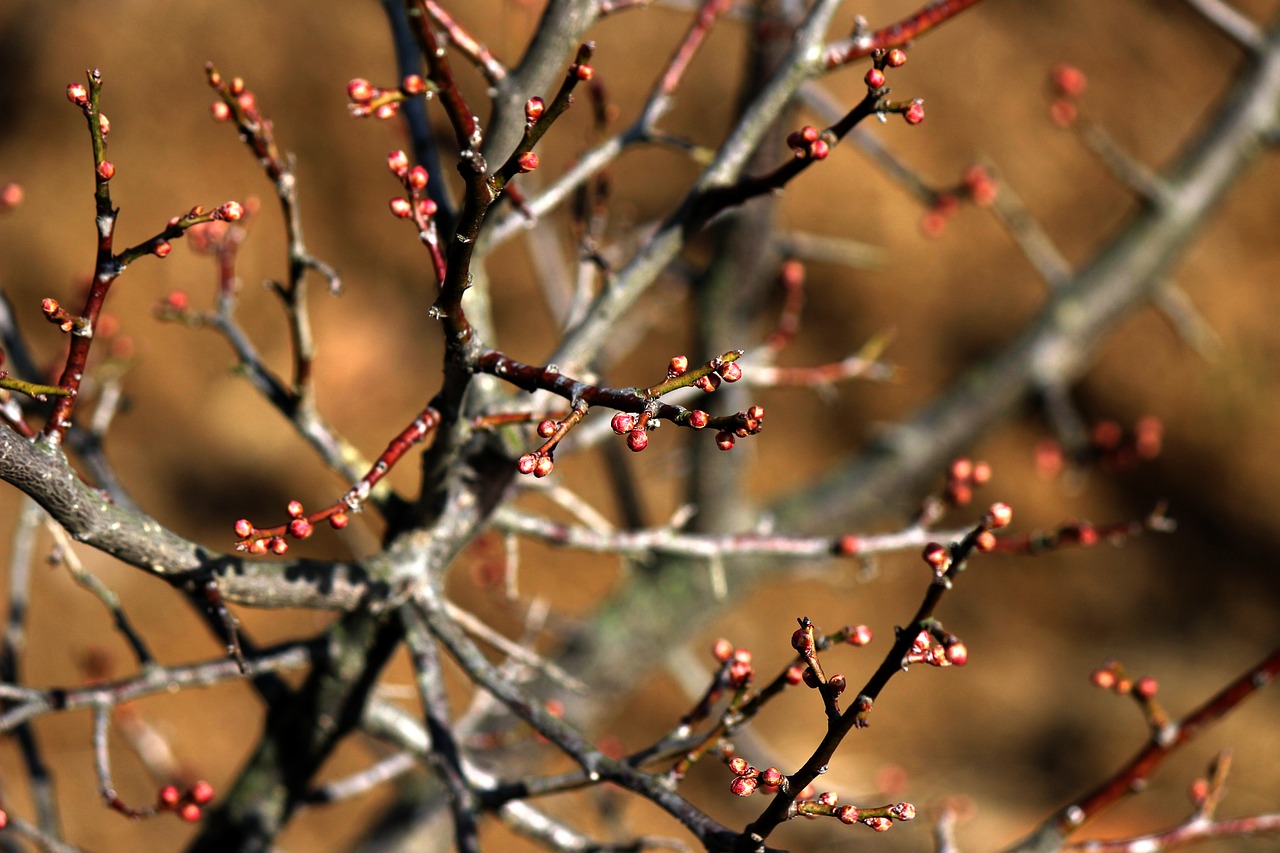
0 0 1280 850
